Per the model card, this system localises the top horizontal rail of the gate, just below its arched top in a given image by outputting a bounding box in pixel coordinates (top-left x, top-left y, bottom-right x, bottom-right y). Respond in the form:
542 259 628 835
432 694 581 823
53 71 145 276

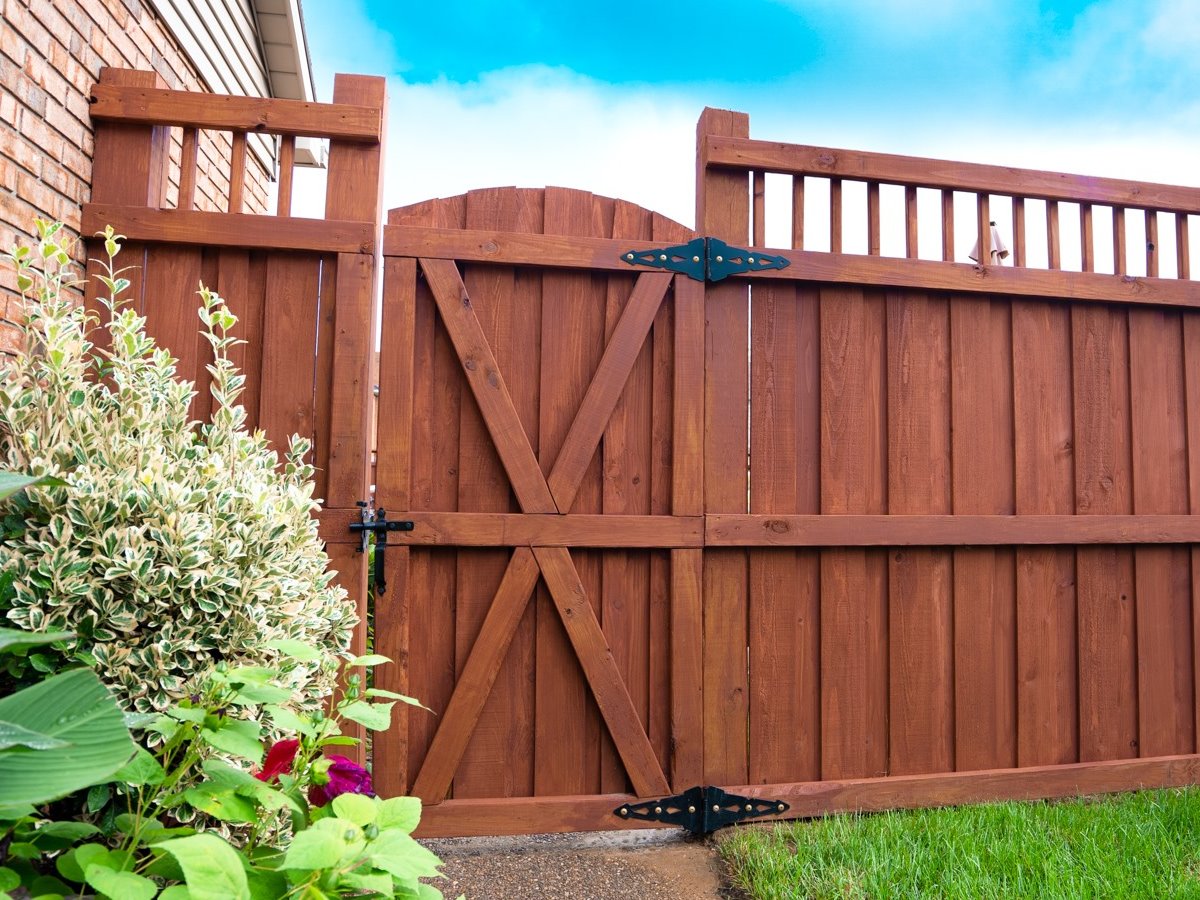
383 224 670 274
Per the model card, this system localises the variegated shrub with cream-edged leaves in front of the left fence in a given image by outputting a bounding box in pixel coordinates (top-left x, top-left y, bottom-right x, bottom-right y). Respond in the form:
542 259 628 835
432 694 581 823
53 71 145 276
0 224 355 712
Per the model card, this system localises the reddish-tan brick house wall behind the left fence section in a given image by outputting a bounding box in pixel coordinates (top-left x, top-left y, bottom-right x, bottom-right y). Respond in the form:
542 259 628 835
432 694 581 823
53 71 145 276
0 0 268 354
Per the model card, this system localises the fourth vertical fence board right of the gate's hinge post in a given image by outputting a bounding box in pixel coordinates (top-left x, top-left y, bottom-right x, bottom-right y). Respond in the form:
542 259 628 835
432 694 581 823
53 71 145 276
950 296 1016 772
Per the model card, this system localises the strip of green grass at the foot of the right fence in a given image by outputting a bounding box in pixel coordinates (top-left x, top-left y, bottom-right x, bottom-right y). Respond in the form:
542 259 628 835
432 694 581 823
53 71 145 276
720 788 1200 900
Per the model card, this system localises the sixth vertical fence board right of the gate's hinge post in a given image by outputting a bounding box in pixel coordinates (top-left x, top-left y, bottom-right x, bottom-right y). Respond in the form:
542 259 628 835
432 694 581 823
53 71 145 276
1072 305 1138 762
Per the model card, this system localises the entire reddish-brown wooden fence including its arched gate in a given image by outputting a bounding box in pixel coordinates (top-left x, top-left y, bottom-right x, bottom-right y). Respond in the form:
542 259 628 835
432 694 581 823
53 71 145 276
77 73 1200 835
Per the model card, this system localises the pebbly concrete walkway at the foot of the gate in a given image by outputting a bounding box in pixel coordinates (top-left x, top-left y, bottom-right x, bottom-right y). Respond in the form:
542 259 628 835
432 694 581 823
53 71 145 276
421 829 742 900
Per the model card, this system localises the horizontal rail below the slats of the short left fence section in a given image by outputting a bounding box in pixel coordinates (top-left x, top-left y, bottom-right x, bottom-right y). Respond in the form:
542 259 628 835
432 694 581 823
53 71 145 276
82 203 376 254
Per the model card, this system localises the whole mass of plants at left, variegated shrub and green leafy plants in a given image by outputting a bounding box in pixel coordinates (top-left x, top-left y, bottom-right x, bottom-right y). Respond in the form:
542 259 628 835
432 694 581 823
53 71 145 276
0 223 440 900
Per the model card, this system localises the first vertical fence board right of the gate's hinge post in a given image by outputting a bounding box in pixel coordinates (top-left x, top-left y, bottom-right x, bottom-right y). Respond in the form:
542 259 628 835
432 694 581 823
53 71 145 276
749 284 821 784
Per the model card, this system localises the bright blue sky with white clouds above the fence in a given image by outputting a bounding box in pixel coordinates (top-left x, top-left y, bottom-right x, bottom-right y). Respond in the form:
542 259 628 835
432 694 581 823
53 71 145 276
295 0 1200 234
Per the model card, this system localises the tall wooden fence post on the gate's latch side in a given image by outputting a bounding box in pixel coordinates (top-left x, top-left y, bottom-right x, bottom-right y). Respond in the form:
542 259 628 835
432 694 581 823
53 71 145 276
322 74 386 762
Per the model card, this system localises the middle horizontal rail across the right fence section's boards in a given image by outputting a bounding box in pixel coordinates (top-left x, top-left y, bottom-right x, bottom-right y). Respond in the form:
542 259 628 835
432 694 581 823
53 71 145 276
704 515 1200 547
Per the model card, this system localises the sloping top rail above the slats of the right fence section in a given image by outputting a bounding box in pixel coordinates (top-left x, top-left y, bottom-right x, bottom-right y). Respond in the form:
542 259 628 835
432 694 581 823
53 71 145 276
702 134 1200 215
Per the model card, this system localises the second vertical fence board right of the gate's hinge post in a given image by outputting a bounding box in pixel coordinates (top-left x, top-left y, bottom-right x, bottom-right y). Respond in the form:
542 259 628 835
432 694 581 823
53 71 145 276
821 287 888 779
